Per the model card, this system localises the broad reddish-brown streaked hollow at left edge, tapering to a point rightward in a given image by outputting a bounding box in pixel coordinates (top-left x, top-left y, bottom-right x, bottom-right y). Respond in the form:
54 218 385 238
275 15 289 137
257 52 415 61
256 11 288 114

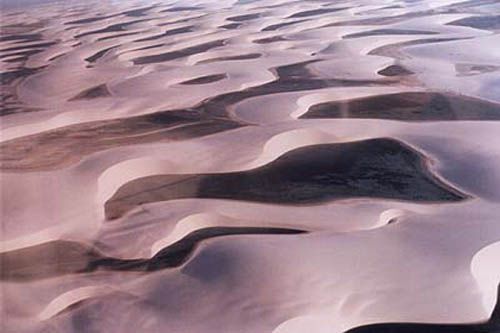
0 109 242 172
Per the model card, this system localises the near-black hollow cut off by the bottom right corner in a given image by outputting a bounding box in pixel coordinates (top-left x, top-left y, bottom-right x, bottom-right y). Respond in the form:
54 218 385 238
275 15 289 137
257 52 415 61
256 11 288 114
345 285 500 333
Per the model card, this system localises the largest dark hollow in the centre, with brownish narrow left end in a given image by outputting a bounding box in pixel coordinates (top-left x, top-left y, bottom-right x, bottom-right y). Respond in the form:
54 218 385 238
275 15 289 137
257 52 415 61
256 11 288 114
105 139 466 219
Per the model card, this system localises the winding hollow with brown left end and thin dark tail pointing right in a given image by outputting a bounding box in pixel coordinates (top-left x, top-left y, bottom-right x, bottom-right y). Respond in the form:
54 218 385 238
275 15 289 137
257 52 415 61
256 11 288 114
0 227 305 282
